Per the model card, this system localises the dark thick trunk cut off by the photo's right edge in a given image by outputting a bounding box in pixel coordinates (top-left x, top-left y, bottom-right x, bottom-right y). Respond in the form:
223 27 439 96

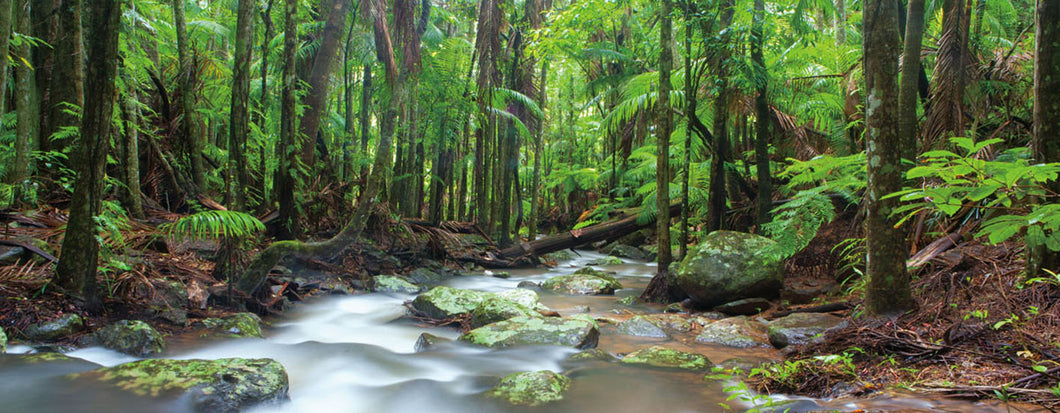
1026 0 1060 277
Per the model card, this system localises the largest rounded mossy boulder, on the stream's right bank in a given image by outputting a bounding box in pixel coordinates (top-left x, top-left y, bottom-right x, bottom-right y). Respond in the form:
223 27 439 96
674 231 783 308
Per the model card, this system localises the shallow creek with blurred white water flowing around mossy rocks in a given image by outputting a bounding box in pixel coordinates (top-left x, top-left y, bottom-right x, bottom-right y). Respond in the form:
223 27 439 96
0 252 1026 413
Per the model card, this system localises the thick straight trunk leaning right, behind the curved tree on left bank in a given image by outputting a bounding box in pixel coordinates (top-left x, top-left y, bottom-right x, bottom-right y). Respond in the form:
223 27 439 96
300 0 350 170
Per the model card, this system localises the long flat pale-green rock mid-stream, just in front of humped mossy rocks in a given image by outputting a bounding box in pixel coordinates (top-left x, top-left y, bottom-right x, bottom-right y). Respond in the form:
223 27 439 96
460 316 600 348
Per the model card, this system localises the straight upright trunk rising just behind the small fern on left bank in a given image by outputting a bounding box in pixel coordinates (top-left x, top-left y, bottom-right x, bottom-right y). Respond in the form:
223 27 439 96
228 0 254 211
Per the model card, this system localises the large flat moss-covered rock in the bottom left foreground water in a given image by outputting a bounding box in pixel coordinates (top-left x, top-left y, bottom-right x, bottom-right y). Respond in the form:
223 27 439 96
66 358 288 412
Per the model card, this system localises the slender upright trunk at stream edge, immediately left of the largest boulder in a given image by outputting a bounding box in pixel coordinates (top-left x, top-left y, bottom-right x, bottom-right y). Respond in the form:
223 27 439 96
640 0 673 302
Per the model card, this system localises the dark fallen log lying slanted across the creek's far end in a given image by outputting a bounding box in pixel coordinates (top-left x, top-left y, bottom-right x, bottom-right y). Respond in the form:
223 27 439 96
500 203 681 261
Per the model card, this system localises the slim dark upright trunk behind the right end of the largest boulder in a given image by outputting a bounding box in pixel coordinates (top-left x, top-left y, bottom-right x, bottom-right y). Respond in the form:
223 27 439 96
750 0 771 229
